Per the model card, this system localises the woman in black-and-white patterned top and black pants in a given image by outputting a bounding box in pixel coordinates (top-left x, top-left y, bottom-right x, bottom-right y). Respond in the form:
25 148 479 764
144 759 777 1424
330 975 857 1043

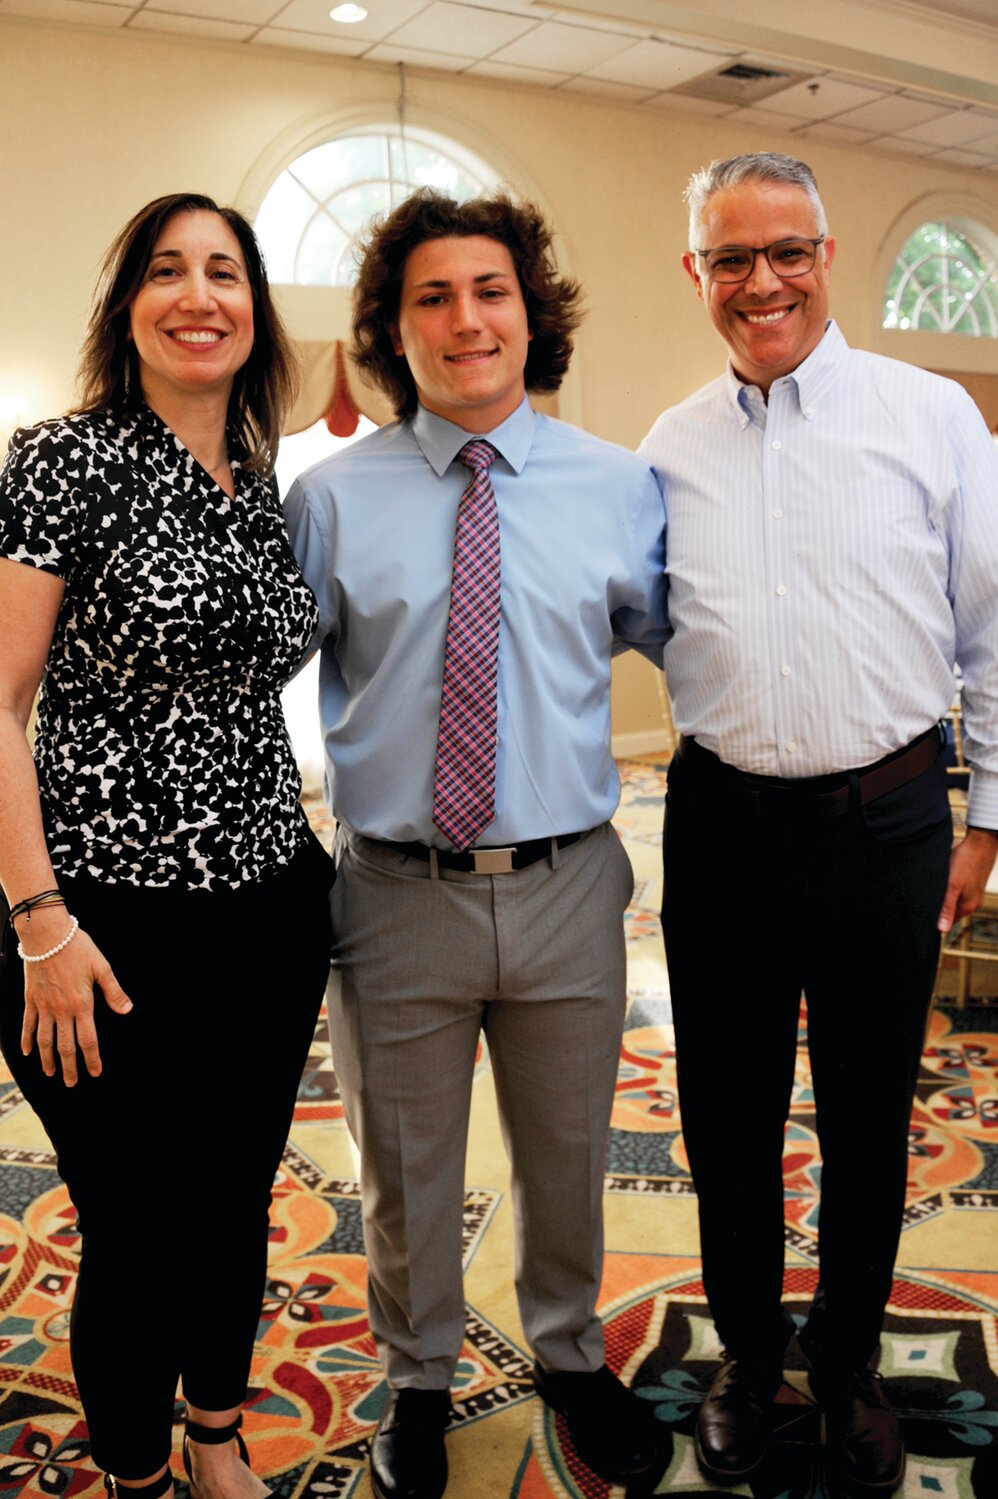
0 195 331 1499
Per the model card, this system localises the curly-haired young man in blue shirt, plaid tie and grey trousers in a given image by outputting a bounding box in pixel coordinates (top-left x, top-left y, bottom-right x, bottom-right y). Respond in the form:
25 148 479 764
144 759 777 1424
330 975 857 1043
288 190 664 1499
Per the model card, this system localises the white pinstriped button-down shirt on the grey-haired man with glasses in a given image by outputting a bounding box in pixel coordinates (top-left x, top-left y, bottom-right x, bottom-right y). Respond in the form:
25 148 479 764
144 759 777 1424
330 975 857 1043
638 322 998 829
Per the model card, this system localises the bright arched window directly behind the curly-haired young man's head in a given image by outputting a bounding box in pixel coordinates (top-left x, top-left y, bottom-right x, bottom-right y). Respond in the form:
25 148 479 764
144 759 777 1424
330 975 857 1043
256 124 498 286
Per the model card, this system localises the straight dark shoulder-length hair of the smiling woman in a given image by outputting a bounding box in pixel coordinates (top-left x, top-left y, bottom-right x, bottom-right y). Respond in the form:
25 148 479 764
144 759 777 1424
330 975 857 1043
76 193 298 474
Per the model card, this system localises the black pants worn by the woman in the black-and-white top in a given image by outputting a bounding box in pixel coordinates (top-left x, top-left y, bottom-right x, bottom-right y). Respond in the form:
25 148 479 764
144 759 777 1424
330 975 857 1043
0 839 333 1480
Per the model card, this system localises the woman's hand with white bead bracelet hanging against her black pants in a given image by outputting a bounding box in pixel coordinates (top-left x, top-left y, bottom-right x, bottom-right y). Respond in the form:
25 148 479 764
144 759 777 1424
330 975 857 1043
19 907 132 1088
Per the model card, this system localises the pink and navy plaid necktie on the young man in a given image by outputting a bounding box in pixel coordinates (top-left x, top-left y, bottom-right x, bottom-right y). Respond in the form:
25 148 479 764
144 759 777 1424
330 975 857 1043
433 438 499 848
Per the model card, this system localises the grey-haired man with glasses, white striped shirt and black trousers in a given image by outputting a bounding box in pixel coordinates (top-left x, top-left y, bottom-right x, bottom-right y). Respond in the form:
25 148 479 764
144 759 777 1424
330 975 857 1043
640 153 998 1495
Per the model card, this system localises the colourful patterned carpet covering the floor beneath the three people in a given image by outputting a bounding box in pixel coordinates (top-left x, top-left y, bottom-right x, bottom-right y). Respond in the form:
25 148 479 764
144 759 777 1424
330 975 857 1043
0 763 998 1499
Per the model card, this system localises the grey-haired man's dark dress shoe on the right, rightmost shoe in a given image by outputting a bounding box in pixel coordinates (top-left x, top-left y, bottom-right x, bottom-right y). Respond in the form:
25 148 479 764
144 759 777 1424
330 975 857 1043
811 1366 905 1499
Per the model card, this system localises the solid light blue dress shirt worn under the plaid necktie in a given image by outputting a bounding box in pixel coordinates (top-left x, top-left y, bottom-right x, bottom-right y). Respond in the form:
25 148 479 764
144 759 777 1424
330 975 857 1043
285 400 665 847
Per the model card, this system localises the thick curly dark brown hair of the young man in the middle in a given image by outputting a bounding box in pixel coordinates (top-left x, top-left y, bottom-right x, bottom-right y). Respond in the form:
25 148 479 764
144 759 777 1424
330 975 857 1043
354 187 583 418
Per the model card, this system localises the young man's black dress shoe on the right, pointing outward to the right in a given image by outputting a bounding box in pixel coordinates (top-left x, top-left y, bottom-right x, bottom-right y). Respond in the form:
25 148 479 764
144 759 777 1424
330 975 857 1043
533 1364 661 1484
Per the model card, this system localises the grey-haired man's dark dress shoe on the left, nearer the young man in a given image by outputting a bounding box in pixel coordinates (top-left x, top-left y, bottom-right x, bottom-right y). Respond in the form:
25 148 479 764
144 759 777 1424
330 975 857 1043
695 1358 782 1484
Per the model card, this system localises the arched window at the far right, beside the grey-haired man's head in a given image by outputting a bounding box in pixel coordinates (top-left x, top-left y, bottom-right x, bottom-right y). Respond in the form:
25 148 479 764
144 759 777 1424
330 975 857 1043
883 219 998 339
